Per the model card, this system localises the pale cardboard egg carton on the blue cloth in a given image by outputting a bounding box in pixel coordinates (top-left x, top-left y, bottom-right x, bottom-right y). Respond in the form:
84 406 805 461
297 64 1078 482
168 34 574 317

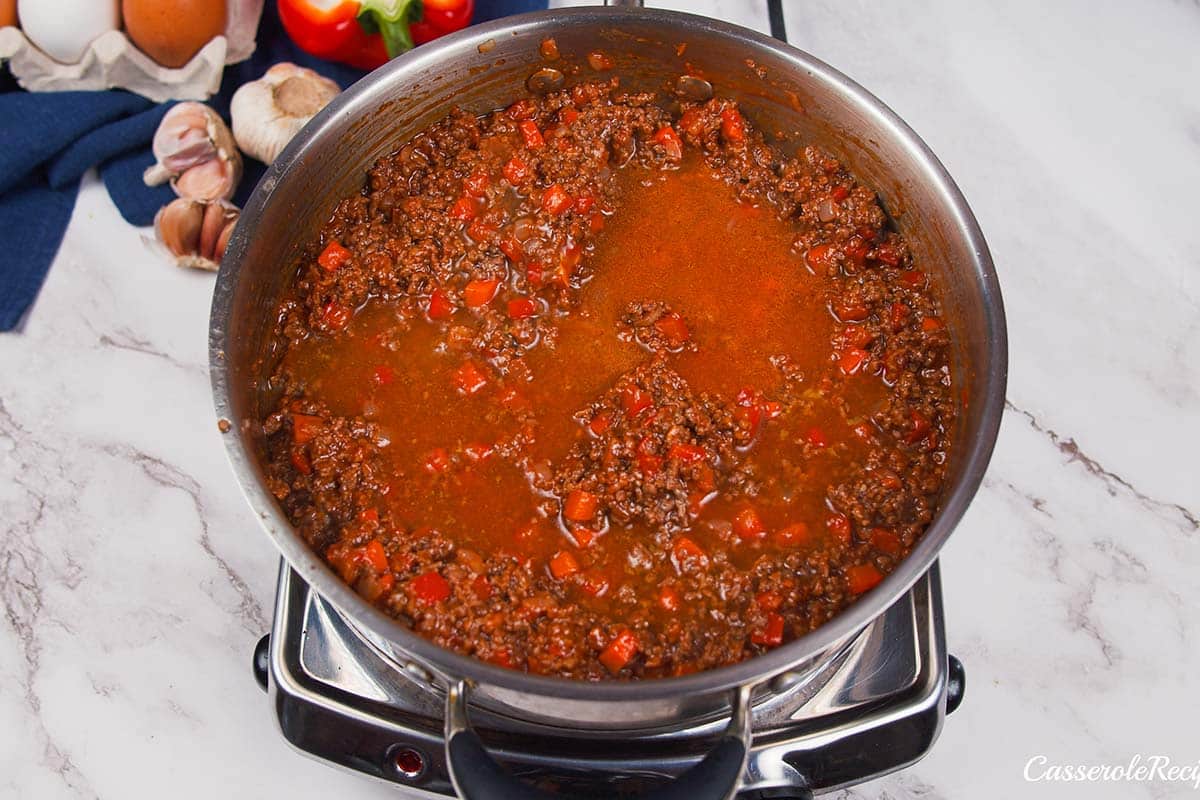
0 0 263 103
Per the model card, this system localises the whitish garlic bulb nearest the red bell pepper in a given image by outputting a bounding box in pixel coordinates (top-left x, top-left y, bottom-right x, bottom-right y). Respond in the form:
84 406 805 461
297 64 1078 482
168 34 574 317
229 61 341 164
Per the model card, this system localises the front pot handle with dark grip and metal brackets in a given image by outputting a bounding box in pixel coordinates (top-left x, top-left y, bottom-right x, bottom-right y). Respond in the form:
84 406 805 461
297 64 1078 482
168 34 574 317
445 681 750 800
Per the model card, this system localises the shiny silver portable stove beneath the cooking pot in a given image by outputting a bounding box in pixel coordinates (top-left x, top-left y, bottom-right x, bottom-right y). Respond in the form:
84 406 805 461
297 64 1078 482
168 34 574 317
254 564 965 800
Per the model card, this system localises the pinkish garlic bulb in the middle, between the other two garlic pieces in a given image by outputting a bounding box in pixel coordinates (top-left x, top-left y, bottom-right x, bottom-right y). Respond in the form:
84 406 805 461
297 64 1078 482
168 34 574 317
142 102 241 200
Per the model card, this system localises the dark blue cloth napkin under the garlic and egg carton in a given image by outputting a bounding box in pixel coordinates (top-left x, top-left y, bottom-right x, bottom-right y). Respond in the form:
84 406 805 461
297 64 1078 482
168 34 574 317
0 0 546 331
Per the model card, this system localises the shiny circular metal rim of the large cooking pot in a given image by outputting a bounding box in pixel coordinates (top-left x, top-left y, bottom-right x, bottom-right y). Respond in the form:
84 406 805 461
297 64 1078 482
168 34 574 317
209 7 1008 702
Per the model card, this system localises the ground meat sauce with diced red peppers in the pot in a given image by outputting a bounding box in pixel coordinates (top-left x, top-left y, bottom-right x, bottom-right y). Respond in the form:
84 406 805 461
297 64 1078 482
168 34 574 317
264 80 954 680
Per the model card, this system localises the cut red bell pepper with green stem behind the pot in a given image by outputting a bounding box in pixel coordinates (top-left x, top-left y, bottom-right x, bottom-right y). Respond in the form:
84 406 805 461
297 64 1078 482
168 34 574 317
278 0 475 70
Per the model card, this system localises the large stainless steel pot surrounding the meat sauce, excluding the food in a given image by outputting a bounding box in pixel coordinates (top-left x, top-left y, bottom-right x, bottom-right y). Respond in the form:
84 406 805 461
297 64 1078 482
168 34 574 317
209 7 1007 796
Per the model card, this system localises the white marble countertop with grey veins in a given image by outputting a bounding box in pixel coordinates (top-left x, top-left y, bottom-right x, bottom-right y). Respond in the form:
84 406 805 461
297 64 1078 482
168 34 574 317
0 0 1200 800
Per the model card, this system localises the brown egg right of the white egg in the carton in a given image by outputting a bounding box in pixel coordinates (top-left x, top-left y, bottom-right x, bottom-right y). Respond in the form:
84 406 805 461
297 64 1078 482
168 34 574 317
121 0 226 67
